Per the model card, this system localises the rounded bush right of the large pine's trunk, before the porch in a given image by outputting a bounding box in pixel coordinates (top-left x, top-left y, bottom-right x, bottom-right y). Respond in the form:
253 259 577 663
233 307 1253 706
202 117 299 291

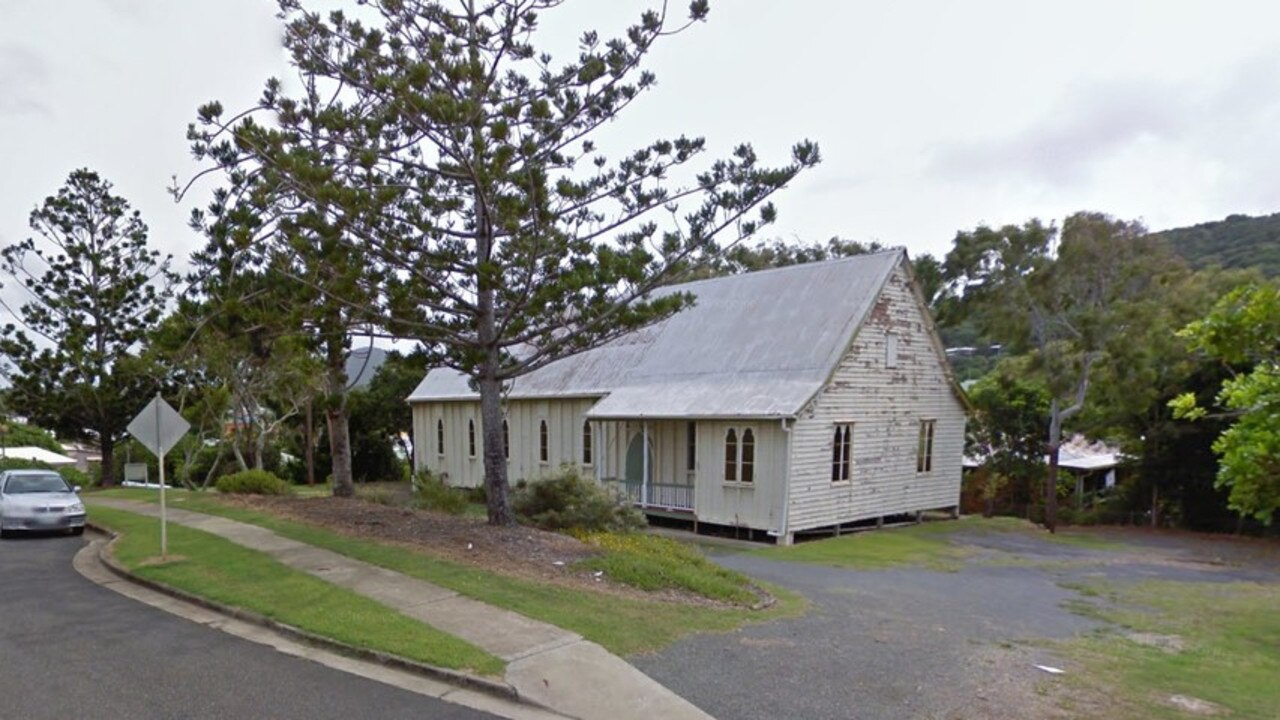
512 465 648 532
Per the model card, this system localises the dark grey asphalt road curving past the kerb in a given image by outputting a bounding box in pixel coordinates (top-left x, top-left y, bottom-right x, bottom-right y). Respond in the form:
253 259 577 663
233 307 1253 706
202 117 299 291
0 537 492 720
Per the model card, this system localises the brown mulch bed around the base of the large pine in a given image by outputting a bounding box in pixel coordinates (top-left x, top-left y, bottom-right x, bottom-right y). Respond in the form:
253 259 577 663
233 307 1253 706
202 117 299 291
227 496 737 606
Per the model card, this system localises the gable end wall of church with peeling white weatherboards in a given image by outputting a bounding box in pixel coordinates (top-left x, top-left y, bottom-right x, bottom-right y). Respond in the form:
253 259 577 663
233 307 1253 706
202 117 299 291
787 260 965 532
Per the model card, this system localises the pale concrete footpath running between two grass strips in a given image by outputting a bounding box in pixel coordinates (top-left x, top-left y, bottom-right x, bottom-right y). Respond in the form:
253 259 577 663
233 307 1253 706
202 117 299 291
91 498 710 720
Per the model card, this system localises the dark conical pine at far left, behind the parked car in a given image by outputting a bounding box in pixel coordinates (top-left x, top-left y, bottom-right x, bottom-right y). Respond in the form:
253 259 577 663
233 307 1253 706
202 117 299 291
0 169 175 486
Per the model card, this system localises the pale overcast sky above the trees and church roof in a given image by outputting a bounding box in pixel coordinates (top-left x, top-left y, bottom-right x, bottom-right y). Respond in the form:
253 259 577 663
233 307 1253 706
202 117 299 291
0 0 1280 274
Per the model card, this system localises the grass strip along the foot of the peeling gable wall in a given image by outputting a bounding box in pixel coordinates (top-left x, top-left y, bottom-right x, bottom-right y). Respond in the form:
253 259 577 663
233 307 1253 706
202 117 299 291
751 516 1124 571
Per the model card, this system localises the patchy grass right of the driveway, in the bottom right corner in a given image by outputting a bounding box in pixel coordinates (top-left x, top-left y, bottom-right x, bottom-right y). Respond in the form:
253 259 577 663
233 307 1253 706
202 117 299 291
1061 582 1280 720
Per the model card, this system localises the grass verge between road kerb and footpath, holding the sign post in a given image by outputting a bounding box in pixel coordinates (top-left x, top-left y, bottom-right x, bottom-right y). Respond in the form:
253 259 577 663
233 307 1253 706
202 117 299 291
92 502 506 675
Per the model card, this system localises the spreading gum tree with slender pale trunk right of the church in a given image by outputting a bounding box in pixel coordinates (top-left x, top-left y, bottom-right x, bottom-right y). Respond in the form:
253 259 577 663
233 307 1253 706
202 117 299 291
943 213 1180 530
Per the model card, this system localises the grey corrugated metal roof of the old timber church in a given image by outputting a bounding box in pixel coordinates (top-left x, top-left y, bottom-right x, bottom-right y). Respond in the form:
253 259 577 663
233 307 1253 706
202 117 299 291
408 250 905 419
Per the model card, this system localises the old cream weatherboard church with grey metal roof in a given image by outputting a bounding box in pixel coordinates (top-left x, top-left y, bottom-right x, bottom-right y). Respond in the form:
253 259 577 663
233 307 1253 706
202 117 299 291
408 250 965 543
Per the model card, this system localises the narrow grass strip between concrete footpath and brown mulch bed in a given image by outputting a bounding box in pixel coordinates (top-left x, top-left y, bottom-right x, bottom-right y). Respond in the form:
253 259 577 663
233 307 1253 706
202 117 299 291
86 489 806 656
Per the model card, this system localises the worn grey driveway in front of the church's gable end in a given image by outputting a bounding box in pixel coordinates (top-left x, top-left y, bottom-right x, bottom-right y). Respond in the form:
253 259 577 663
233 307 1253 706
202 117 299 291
631 520 1280 720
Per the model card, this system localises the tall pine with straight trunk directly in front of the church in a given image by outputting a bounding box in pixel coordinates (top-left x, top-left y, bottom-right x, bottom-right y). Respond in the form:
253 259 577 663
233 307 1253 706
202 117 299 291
189 0 819 524
